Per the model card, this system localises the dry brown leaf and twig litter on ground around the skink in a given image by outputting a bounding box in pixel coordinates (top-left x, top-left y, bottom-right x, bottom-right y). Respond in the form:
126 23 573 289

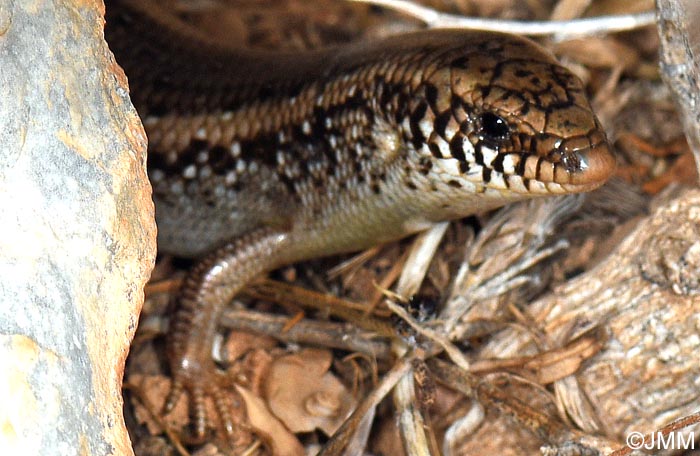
125 0 700 456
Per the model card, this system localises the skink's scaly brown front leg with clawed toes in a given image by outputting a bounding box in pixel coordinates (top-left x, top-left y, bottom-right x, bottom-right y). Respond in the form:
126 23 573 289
165 228 289 439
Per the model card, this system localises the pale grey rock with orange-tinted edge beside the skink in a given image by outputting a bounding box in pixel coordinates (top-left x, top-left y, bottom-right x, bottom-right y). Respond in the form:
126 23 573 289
0 0 155 455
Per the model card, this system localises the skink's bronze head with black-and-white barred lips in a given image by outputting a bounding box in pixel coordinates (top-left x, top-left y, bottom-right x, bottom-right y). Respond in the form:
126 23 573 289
411 31 615 199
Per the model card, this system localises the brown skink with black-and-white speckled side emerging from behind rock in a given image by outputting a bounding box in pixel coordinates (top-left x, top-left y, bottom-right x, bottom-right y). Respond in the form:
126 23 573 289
106 0 615 442
